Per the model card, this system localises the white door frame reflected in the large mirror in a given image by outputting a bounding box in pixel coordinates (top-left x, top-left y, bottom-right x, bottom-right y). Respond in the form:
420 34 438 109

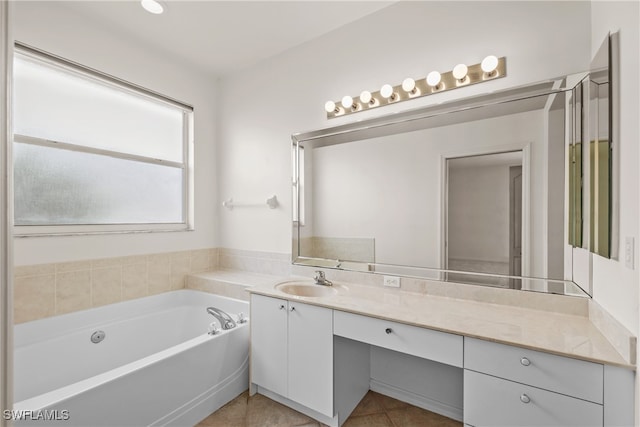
438 142 532 277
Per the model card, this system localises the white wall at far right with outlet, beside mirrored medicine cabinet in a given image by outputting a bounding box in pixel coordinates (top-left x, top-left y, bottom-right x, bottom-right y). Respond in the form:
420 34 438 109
591 1 640 425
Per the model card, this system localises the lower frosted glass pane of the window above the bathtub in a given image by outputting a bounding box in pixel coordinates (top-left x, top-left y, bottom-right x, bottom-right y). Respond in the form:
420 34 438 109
14 143 184 225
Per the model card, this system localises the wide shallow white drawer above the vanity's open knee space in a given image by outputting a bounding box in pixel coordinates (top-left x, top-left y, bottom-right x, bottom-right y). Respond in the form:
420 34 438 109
333 310 463 367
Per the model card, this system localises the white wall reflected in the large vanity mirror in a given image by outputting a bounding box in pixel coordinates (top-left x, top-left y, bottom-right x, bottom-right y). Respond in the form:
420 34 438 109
303 110 562 278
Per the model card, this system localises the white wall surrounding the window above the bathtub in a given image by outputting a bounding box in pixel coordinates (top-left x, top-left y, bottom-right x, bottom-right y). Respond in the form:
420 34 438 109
13 2 218 265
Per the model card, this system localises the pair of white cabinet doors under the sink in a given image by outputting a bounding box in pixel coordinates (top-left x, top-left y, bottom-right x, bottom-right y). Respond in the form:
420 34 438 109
251 294 334 417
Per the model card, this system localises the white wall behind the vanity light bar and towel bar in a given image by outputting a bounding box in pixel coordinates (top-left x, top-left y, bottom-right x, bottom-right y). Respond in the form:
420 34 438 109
218 1 590 253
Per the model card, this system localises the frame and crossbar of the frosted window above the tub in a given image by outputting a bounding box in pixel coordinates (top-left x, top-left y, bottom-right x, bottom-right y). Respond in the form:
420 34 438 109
11 42 194 237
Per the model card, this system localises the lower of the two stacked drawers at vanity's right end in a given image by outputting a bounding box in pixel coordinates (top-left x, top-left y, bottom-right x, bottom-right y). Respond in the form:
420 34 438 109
464 369 603 427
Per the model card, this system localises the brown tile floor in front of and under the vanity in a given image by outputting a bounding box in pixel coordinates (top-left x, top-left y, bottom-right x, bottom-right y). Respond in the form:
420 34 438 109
196 391 462 427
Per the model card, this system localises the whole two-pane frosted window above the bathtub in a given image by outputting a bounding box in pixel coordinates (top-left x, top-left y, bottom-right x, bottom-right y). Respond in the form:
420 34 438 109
13 46 193 235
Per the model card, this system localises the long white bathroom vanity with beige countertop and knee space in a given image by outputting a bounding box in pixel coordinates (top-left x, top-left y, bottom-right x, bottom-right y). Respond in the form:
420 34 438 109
250 281 635 426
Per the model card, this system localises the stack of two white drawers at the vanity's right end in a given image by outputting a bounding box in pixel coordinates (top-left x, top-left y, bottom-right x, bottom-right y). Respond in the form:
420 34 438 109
464 338 604 427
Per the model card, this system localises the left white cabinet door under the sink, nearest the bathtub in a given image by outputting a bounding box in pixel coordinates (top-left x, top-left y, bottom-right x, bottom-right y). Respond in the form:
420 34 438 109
250 295 287 396
